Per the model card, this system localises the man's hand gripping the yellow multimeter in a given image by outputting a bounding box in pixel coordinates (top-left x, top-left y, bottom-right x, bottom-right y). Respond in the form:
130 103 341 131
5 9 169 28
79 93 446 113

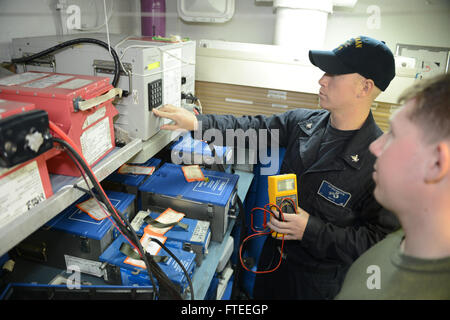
267 208 309 240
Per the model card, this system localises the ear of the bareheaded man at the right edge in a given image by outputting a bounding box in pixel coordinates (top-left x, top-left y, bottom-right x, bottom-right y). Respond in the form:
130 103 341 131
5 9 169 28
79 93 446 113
425 141 450 183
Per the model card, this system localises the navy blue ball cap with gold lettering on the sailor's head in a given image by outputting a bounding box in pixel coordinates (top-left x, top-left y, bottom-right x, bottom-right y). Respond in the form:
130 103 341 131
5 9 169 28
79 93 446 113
309 36 395 91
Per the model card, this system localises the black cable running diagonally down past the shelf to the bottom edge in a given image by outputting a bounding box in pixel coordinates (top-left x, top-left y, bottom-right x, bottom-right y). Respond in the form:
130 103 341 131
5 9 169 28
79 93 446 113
54 138 182 300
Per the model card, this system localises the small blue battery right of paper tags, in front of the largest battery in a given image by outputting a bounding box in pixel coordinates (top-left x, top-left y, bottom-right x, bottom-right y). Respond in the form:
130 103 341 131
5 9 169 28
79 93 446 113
131 211 211 266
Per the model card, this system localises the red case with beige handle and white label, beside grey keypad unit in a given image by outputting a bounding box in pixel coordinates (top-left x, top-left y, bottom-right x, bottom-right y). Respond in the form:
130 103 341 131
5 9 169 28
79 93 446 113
0 71 121 176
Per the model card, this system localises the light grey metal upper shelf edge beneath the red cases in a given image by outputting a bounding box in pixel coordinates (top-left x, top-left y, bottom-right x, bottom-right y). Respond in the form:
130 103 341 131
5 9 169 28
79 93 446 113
0 139 142 256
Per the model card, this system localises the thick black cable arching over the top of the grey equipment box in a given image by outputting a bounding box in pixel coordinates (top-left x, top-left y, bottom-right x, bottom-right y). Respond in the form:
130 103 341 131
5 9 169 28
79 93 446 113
11 38 121 87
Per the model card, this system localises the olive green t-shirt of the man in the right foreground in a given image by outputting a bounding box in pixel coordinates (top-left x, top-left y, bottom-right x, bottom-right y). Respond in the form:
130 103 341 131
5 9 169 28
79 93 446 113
336 230 450 300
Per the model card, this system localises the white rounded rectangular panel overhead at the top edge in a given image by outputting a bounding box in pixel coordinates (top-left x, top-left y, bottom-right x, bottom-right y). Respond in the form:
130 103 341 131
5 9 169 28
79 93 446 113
177 0 234 23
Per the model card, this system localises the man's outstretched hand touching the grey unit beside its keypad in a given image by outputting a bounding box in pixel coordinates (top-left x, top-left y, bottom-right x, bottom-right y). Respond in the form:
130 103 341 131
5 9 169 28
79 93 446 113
153 104 198 131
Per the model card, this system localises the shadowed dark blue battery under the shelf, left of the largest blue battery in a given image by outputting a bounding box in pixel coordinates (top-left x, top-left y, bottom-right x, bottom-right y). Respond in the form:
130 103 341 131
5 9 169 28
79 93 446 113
102 158 161 214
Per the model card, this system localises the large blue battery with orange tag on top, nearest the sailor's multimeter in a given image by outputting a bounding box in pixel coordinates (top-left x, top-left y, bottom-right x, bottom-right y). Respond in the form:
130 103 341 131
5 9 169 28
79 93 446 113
139 163 239 242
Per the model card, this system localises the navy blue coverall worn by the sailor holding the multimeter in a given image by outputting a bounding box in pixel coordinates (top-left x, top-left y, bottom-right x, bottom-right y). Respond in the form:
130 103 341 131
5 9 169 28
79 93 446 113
197 109 399 299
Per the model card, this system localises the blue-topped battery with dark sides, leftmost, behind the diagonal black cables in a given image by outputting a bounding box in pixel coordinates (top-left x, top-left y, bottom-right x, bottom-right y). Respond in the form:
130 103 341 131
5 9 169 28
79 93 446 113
22 191 135 277
